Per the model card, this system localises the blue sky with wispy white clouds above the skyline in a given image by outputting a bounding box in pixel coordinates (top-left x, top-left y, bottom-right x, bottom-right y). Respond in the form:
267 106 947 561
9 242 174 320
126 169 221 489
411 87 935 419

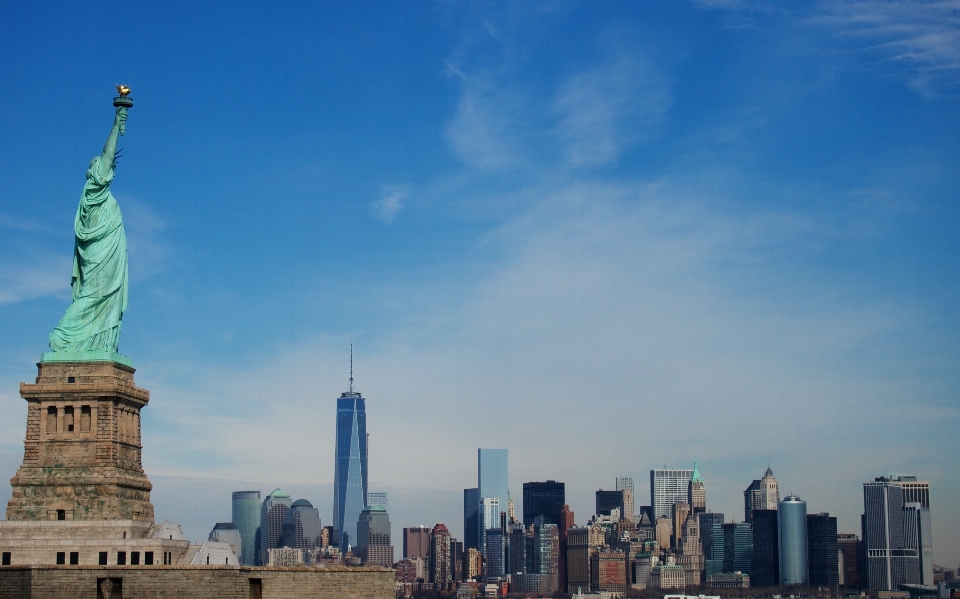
0 0 960 565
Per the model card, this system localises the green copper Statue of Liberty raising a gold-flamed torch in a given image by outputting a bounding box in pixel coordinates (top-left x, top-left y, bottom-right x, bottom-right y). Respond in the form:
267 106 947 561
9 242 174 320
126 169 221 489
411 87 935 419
41 86 133 363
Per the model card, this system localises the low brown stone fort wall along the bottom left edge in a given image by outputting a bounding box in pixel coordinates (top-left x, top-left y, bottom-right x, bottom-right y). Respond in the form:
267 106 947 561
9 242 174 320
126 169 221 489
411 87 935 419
0 566 396 599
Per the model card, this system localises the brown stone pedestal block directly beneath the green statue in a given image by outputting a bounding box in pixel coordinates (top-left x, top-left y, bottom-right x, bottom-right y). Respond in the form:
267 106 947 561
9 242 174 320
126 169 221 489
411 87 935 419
7 361 153 524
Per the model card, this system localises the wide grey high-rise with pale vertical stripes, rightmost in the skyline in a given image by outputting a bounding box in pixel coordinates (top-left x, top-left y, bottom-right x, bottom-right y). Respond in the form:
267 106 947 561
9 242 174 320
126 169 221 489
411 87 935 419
861 474 932 591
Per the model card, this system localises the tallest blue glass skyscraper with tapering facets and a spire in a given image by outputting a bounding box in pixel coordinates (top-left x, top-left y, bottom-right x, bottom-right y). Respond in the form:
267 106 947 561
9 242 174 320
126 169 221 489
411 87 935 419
333 346 367 551
